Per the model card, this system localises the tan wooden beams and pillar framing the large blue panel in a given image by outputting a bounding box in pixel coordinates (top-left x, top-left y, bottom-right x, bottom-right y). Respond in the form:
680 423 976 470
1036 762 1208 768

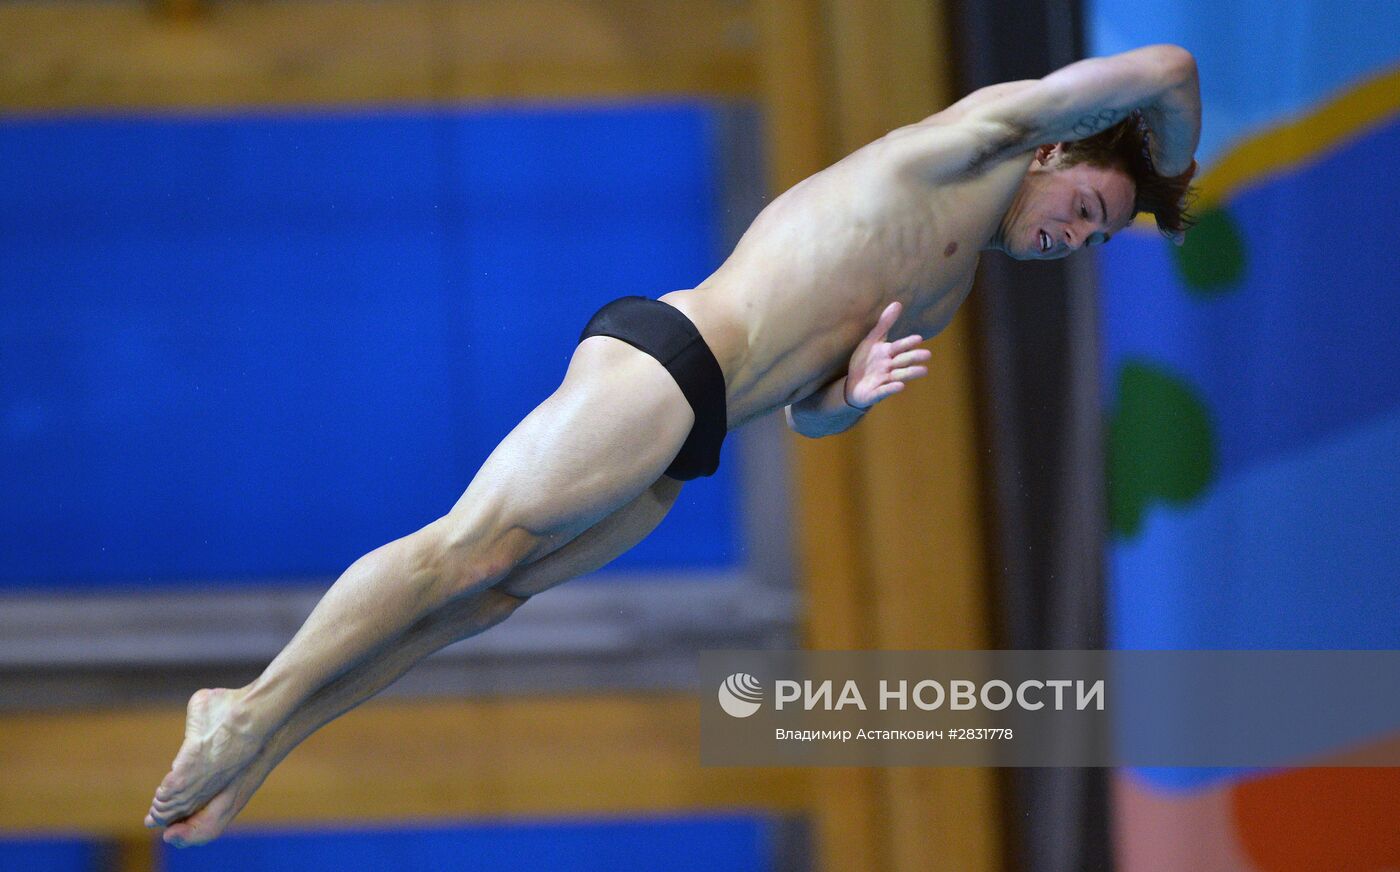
0 0 1002 872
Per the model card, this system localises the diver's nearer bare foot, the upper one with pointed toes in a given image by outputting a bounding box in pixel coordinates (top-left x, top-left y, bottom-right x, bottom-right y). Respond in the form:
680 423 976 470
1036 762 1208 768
146 689 265 827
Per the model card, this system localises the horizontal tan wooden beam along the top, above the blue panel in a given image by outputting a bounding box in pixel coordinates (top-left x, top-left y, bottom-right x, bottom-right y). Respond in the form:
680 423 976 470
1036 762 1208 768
0 0 757 112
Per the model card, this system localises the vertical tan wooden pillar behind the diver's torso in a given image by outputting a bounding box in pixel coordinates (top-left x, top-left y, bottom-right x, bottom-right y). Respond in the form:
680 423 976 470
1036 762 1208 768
760 0 1002 872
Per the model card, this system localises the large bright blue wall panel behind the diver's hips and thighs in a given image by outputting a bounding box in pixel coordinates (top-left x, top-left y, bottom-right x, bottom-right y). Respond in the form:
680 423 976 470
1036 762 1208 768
0 104 739 586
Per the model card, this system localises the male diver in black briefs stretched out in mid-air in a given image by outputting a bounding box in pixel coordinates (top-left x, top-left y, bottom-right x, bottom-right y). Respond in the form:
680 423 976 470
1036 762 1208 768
146 45 1201 845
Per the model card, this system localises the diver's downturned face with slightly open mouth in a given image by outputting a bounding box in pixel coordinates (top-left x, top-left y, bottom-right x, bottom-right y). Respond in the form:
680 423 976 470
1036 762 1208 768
1002 146 1134 260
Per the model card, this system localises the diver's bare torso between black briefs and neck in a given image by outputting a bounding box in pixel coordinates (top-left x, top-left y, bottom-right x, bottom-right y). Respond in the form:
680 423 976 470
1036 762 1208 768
662 109 1032 427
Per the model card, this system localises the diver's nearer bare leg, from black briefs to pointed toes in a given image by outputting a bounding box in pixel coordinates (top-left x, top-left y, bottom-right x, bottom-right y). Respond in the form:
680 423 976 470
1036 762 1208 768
151 336 694 824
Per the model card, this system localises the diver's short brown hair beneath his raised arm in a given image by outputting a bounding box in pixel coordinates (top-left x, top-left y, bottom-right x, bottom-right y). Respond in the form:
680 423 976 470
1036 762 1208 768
1063 111 1196 234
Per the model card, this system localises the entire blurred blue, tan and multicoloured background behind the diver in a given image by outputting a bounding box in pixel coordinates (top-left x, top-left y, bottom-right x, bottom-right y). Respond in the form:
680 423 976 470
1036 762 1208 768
0 0 1400 872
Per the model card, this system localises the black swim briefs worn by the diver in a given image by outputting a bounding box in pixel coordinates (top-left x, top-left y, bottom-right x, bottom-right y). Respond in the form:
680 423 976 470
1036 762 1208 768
578 297 729 481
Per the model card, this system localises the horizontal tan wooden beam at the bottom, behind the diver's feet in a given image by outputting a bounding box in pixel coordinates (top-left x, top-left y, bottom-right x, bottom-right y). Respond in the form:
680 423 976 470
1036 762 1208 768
0 694 809 872
